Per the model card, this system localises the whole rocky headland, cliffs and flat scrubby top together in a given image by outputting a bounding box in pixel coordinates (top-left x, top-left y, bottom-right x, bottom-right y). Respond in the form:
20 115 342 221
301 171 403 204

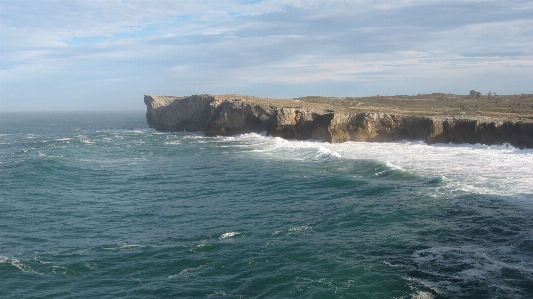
144 93 533 149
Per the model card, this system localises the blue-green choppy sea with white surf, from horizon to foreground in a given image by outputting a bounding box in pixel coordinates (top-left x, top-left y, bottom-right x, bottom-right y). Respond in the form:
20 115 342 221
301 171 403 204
0 112 533 299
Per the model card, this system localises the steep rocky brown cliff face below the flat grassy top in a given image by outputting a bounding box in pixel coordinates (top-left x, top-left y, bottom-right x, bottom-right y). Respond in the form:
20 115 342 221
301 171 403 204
144 95 533 148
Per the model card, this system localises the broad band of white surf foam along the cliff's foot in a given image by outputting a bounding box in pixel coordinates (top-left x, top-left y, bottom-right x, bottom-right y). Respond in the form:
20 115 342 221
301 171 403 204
224 134 533 201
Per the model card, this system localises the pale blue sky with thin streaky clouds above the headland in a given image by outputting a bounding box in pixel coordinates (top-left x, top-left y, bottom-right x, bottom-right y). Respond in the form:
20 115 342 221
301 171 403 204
0 0 533 112
